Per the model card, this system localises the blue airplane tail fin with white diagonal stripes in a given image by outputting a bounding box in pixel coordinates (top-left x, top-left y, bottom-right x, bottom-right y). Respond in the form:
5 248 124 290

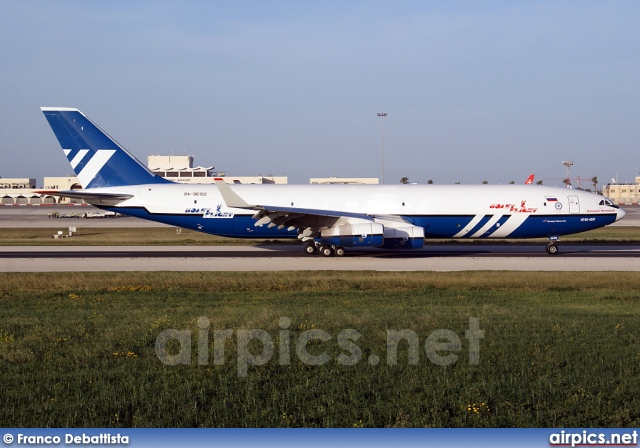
40 107 169 188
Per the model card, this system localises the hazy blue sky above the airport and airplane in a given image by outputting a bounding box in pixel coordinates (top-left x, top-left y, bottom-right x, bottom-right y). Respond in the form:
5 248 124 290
0 0 640 185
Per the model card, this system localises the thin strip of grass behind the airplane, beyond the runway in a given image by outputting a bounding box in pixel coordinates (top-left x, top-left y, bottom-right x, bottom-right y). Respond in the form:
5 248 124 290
0 223 640 246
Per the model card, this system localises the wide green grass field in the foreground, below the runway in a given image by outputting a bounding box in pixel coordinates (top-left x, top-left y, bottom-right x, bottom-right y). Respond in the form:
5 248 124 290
0 272 640 427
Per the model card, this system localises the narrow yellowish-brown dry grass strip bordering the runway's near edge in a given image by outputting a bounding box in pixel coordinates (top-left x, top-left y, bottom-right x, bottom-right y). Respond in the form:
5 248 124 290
0 271 640 294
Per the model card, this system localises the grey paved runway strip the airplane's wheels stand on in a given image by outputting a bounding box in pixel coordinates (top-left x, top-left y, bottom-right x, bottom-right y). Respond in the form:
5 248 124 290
0 244 640 272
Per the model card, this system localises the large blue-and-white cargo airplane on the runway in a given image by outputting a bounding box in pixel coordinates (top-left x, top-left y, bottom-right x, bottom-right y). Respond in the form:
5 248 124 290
42 107 625 256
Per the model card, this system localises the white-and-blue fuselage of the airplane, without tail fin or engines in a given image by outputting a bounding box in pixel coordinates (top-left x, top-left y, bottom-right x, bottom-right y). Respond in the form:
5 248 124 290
94 183 624 242
